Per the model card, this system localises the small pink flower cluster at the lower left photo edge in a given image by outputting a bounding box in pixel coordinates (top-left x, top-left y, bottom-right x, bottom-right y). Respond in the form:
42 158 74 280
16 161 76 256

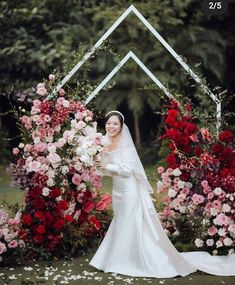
0 206 25 266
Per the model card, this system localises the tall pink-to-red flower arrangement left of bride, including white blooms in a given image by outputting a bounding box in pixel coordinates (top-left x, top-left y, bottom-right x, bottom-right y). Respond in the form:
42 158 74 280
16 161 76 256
11 74 111 254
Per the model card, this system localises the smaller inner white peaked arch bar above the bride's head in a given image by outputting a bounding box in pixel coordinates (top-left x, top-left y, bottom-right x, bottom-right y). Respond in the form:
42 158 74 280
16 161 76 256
85 51 176 105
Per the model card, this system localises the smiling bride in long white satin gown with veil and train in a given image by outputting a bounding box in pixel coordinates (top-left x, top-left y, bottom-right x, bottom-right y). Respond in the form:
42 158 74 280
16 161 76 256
89 111 235 278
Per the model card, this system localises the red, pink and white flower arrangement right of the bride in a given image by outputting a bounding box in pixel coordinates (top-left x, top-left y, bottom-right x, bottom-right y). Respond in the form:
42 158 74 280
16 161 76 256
157 101 235 255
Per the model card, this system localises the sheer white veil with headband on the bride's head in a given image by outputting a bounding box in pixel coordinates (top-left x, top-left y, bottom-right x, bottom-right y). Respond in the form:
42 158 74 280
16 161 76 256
105 111 153 193
